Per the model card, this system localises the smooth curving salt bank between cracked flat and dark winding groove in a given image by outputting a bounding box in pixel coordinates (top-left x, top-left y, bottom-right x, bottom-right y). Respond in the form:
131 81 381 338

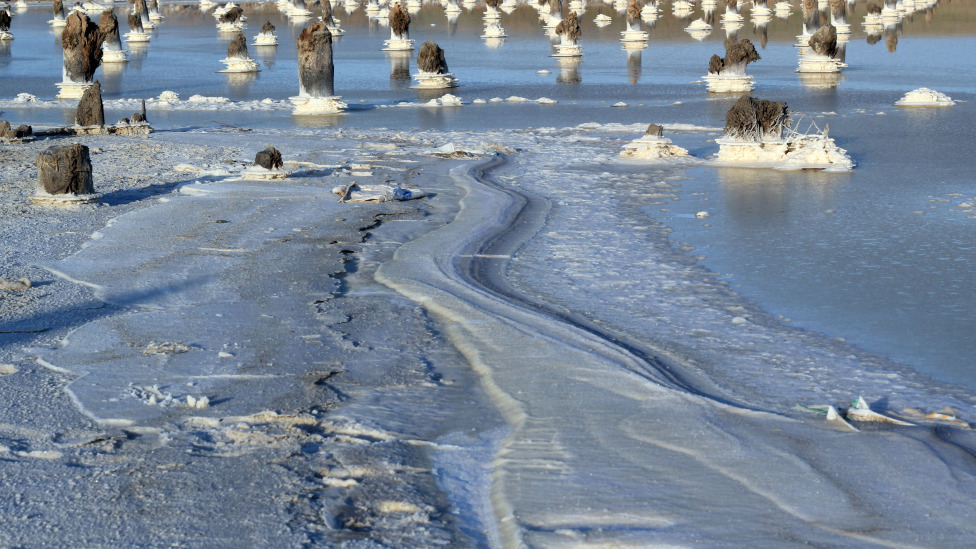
376 152 976 547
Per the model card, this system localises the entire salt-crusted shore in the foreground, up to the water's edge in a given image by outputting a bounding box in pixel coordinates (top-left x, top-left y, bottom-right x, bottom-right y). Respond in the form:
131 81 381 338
0 125 976 547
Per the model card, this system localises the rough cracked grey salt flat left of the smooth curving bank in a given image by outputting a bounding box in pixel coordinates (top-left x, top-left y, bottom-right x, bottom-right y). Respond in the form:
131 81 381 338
0 127 504 547
